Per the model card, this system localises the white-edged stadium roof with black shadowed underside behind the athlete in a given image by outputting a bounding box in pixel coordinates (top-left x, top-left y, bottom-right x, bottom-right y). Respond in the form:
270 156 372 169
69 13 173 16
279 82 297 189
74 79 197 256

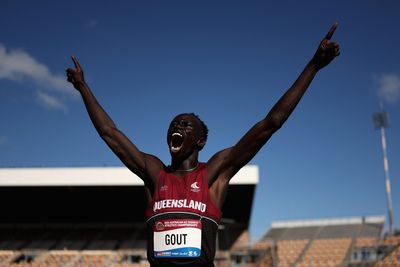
0 165 258 249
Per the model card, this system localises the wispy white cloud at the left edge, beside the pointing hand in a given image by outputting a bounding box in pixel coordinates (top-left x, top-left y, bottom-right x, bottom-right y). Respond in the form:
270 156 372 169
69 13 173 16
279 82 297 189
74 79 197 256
0 43 77 108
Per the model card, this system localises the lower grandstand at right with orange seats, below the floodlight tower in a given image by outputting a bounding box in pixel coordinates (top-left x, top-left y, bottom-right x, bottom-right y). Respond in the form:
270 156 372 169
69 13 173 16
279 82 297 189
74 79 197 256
231 216 400 267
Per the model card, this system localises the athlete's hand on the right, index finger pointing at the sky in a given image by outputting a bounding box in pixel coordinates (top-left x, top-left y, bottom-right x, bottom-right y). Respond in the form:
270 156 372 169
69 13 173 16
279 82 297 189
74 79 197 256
311 22 340 70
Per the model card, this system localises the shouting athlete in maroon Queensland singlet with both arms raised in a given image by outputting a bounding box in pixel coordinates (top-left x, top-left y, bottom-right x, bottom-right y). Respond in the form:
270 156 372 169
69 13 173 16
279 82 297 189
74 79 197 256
66 23 339 266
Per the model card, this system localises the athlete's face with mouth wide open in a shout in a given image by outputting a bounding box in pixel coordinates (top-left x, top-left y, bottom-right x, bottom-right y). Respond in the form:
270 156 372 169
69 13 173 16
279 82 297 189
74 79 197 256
167 114 204 156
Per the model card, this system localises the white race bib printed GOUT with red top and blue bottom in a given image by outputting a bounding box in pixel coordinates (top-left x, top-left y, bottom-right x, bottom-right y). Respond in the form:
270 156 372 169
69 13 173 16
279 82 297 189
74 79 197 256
153 219 201 258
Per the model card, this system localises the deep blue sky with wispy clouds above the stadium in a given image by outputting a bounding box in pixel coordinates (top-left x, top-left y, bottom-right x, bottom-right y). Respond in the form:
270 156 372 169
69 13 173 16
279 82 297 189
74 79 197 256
0 0 400 243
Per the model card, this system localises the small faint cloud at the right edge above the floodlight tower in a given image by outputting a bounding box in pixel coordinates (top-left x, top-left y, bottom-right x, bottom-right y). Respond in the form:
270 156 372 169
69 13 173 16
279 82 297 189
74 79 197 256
377 74 400 104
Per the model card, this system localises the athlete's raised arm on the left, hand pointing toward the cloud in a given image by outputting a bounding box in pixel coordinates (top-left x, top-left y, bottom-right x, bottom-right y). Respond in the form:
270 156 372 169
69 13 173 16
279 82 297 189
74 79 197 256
66 56 163 189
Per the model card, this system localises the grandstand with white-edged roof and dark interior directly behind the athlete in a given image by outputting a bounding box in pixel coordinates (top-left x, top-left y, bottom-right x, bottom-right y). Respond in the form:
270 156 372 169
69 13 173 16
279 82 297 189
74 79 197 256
0 165 258 267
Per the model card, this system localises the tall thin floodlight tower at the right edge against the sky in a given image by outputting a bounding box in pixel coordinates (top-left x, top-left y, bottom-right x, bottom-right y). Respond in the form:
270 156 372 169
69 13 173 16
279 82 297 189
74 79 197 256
373 111 393 235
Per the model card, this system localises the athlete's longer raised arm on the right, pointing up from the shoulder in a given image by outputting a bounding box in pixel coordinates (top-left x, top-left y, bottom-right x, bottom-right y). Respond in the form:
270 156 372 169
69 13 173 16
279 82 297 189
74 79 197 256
207 23 339 188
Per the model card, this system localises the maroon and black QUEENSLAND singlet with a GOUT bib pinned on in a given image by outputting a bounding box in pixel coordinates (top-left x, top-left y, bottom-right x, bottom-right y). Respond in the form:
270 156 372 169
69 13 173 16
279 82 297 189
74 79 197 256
146 163 222 266
